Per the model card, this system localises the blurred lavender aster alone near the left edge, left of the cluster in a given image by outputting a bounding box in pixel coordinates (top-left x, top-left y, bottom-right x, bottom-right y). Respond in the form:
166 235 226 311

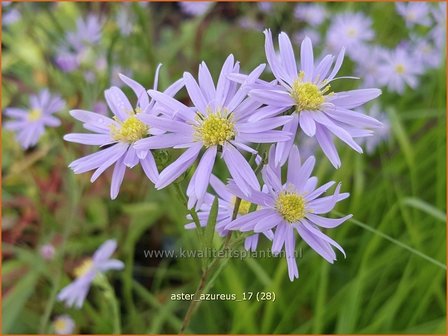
4 90 65 149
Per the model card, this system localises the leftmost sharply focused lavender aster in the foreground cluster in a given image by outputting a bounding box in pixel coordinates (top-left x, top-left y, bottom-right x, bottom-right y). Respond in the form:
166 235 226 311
64 68 182 199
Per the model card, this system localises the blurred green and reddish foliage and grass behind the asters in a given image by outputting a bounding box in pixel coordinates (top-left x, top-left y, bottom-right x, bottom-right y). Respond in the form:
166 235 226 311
2 2 446 334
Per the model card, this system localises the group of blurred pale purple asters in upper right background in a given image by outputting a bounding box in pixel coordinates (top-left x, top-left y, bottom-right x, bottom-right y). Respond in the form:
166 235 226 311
288 2 446 153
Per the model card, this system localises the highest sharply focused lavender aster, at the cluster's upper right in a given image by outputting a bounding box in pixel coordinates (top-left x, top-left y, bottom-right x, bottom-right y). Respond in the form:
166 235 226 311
249 30 381 168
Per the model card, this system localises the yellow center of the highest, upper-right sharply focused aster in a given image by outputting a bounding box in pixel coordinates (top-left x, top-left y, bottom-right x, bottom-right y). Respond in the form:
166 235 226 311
291 71 330 112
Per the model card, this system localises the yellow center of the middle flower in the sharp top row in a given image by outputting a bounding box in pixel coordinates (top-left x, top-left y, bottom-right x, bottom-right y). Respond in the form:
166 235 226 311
195 113 235 147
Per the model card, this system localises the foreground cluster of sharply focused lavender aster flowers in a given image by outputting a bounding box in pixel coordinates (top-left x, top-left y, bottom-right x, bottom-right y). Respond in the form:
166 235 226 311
60 30 382 284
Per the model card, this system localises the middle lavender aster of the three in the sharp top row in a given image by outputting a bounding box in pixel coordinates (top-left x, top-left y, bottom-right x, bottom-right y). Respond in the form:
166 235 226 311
135 55 291 209
